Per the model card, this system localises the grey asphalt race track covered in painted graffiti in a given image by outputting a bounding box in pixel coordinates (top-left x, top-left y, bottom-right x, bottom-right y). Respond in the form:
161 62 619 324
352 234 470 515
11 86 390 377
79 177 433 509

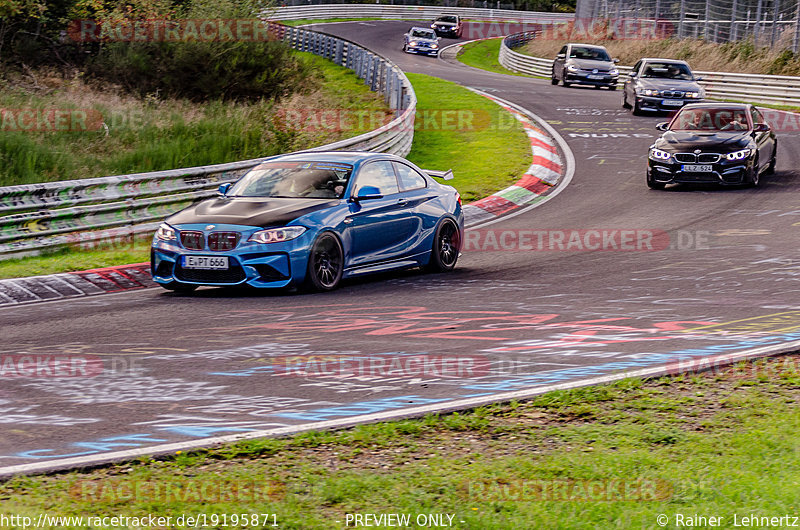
0 21 800 473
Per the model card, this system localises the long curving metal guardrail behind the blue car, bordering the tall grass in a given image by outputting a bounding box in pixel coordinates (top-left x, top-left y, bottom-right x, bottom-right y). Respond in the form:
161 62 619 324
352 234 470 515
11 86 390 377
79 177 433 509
0 23 417 259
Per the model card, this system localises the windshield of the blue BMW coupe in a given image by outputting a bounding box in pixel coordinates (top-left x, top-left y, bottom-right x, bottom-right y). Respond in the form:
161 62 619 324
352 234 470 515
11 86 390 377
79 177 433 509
228 161 353 199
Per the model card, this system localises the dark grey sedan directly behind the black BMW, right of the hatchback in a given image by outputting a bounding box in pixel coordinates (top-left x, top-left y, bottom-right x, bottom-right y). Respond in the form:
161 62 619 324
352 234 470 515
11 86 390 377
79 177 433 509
622 59 705 115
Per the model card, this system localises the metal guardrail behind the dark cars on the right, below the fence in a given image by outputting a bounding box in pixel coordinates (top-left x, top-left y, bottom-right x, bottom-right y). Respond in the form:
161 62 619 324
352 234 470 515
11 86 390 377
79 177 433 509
498 32 800 106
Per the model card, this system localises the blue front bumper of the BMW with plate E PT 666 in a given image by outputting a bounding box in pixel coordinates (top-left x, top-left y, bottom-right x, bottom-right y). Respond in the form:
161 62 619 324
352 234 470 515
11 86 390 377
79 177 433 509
150 225 315 288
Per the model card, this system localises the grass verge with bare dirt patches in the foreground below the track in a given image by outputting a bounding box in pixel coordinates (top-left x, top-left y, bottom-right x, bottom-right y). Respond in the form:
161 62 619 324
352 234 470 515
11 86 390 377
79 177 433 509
0 356 800 529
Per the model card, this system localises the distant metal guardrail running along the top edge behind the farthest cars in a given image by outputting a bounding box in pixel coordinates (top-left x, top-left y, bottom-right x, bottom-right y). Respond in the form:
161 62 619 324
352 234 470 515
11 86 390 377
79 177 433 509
264 4 575 23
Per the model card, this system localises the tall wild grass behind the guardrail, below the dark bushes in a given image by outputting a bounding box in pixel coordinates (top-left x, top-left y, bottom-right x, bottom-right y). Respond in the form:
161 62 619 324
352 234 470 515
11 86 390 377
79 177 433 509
0 52 388 186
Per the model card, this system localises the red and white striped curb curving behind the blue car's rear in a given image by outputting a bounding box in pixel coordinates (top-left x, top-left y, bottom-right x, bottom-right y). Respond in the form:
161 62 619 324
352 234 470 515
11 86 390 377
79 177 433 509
464 88 569 227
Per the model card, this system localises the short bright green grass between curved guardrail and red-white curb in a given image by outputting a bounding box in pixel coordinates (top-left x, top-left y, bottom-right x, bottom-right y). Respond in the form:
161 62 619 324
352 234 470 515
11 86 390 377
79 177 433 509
407 74 531 202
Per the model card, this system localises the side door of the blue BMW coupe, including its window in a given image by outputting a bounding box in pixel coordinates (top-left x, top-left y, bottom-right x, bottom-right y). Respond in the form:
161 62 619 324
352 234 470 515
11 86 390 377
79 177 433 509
345 160 418 267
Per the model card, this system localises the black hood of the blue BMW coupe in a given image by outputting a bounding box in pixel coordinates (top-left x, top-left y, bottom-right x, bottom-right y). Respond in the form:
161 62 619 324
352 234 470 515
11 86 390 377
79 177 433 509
166 197 339 228
